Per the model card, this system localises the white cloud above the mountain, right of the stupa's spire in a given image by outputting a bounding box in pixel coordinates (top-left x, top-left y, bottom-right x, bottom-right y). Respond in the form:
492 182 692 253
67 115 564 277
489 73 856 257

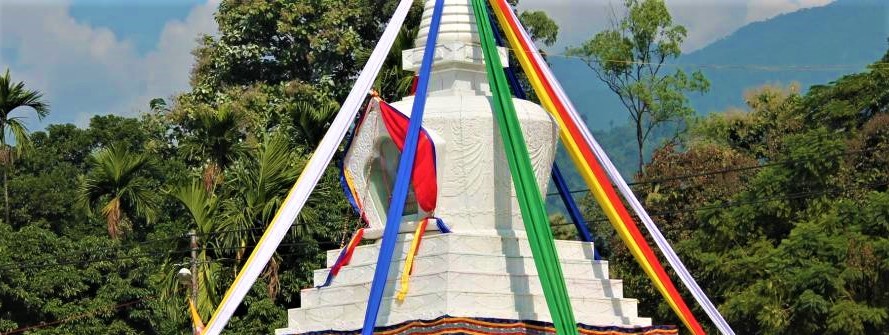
519 0 834 52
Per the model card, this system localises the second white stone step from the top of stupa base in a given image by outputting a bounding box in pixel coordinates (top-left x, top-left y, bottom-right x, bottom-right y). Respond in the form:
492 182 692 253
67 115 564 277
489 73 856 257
314 253 609 286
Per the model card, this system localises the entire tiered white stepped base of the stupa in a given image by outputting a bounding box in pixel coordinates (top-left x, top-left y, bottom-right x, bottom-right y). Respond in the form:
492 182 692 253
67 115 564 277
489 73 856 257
277 233 652 334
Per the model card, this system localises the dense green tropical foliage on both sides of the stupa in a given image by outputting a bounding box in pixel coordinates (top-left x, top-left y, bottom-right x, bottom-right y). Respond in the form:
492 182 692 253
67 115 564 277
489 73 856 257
0 0 889 334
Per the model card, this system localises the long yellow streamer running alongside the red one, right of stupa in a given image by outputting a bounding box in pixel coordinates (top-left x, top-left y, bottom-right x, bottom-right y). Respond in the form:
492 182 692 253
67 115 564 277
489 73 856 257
491 0 690 327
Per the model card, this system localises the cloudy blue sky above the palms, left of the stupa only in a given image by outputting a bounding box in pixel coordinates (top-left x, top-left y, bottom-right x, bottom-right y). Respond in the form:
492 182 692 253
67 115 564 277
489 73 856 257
0 0 218 129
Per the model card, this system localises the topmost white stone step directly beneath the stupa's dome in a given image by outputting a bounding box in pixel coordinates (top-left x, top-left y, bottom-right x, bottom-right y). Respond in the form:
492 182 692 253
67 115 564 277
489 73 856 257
327 233 594 268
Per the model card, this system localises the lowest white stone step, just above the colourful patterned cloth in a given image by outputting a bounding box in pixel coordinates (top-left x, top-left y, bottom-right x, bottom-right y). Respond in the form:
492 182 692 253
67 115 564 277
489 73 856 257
288 291 651 333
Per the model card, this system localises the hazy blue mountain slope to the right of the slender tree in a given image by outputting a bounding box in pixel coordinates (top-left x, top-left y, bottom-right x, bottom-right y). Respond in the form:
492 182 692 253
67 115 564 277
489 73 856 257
679 0 889 113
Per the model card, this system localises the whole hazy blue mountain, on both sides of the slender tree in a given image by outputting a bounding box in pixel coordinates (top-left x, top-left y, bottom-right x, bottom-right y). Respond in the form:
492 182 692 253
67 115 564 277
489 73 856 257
549 0 889 130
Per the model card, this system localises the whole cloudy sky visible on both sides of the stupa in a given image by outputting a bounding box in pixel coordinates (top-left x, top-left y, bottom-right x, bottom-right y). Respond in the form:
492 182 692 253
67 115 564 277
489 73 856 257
0 0 832 129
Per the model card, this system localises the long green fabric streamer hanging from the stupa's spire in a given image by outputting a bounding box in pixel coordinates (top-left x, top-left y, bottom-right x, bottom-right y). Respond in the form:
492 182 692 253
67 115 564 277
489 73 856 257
472 0 578 335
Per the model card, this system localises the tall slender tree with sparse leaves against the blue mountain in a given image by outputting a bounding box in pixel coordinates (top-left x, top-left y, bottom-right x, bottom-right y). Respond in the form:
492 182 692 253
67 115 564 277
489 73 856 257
566 0 709 172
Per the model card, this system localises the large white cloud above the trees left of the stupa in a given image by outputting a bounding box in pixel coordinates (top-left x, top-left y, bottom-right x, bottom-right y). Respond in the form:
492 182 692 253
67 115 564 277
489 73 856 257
0 0 218 127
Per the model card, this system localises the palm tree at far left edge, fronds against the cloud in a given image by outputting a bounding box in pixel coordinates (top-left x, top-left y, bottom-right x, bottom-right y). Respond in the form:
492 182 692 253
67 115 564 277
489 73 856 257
0 69 49 224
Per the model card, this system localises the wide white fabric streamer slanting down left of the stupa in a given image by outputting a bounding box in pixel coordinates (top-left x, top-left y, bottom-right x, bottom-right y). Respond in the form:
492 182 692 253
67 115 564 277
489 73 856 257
203 0 413 335
